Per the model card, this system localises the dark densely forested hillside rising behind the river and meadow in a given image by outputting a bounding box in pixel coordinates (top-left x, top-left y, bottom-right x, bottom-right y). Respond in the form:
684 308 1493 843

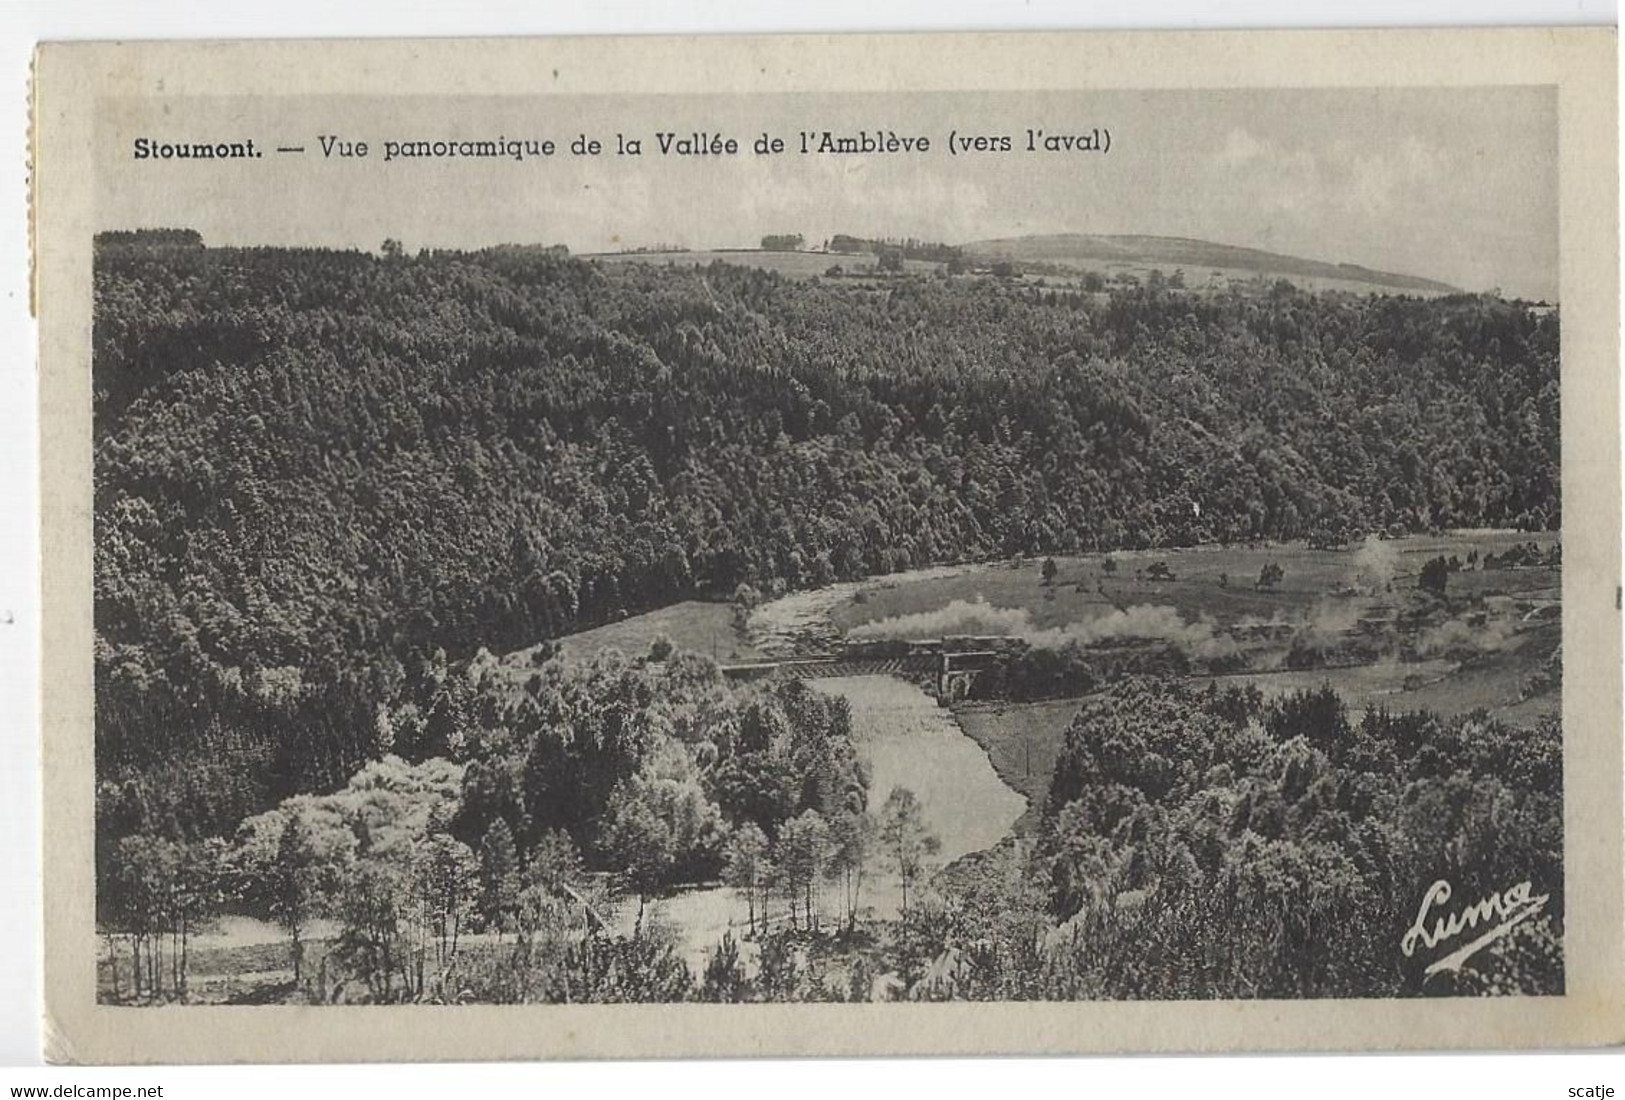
93 236 1560 835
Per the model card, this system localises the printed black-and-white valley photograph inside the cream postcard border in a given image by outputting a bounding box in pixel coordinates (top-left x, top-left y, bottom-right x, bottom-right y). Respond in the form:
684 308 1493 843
91 88 1563 1006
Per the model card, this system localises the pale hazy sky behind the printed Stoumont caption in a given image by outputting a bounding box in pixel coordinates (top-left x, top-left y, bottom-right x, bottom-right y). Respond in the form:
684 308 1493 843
98 88 1558 301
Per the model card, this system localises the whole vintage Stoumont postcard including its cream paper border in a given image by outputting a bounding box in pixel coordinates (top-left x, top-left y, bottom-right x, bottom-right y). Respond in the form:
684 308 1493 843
33 29 1625 1061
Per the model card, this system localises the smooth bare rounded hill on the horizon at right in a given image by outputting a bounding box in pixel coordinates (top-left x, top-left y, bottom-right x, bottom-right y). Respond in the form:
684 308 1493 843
962 232 1461 294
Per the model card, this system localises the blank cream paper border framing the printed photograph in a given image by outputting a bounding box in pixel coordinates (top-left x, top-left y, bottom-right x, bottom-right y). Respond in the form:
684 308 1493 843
34 29 1625 1063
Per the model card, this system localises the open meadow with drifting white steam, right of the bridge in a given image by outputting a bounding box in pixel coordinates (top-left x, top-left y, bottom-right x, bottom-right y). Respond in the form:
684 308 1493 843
826 531 1562 721
